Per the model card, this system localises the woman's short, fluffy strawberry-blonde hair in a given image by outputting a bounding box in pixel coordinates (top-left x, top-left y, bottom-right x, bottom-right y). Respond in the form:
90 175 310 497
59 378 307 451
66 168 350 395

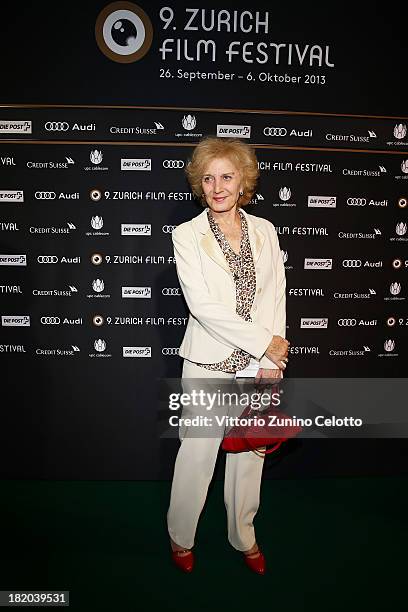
186 136 259 207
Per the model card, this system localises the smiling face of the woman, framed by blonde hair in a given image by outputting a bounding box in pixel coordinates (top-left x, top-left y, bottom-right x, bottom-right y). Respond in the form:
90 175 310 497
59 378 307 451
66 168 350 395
201 157 242 212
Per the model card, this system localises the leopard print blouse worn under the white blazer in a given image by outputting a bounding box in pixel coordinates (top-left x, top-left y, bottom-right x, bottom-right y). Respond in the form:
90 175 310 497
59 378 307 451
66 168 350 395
196 208 256 372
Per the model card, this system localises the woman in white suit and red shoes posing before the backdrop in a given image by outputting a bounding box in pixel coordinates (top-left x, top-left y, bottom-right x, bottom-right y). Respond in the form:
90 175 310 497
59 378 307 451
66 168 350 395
167 137 289 574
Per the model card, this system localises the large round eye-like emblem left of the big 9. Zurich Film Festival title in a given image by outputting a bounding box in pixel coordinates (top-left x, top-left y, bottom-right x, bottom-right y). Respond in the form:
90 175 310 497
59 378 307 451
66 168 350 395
95 2 153 64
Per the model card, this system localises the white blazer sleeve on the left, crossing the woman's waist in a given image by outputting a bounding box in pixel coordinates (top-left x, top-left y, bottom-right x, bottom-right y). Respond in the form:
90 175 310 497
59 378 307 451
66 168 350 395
172 226 273 359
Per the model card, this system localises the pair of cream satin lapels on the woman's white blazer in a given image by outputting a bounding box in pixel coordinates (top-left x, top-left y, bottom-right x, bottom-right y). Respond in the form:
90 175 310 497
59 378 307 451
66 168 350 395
192 209 265 274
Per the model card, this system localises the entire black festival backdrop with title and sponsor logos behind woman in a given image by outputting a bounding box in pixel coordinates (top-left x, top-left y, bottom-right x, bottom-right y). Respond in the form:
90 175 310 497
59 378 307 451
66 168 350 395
0 2 408 479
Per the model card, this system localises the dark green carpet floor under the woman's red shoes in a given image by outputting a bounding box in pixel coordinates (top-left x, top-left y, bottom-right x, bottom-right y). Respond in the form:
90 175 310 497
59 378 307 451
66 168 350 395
0 477 408 612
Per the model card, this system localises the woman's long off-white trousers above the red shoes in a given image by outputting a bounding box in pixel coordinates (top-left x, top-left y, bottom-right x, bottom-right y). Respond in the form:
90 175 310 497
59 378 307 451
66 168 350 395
167 359 264 551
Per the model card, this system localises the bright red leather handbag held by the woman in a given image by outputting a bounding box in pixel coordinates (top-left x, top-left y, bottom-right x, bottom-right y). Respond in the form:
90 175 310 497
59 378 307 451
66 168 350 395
221 385 302 457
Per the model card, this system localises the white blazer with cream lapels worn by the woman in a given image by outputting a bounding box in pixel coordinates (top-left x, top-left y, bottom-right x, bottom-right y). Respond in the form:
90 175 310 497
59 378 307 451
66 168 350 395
172 209 286 369
